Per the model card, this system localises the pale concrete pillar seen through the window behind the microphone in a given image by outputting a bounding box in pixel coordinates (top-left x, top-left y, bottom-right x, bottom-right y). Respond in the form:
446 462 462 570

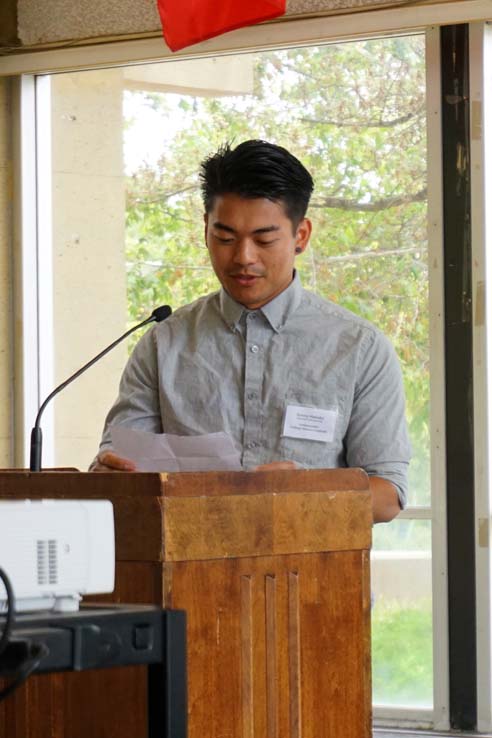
51 69 127 462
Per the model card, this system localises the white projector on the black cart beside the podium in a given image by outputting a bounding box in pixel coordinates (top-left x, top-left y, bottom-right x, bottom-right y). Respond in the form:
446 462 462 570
0 500 115 613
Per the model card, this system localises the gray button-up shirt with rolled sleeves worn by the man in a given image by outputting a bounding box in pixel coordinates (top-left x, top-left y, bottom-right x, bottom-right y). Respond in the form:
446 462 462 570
101 276 410 504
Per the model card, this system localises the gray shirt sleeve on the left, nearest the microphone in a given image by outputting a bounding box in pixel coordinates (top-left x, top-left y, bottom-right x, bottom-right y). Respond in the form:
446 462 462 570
92 328 162 460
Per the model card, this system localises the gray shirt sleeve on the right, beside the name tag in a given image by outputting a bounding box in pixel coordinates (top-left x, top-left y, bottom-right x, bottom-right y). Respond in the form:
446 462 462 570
345 331 411 508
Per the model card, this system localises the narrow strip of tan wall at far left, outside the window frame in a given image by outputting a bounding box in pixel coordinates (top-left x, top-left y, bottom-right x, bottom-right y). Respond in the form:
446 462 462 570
0 78 13 467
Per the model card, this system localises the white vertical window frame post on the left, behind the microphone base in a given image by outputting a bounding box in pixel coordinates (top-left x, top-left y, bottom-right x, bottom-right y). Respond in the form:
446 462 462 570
12 75 54 468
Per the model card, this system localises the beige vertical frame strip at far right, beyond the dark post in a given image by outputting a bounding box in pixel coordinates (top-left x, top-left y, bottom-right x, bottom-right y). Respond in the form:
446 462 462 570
469 17 492 732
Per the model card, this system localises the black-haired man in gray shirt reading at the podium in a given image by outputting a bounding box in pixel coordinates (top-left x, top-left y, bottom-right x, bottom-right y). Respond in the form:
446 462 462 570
91 141 410 522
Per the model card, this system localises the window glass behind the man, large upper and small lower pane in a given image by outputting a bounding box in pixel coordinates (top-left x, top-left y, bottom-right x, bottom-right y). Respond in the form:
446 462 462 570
46 35 432 707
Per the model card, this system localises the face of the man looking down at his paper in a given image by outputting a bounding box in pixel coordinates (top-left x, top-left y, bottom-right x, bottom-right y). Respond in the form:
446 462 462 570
205 194 311 310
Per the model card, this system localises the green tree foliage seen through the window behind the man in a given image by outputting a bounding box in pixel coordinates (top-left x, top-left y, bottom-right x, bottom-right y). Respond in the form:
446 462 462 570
127 36 430 504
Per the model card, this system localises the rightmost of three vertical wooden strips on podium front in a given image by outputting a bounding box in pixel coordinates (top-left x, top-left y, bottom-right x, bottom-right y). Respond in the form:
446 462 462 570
288 571 302 738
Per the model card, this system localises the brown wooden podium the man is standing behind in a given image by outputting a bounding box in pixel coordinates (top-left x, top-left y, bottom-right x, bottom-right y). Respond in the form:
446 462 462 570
0 469 372 738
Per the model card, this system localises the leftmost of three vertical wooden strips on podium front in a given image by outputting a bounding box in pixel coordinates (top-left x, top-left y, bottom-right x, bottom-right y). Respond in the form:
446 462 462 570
241 576 254 738
